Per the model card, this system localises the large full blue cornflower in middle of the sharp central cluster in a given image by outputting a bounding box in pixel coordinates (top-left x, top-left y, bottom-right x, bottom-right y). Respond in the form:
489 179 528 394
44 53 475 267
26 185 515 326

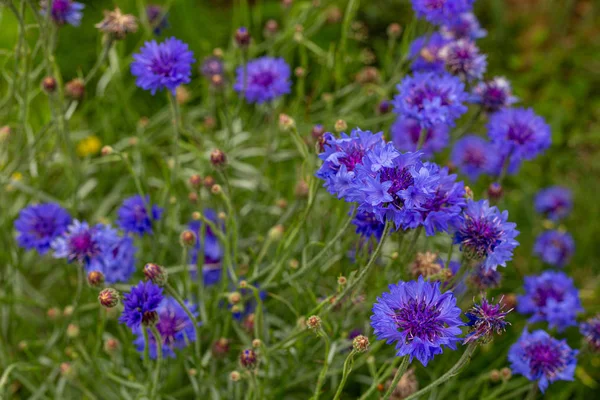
352 143 438 229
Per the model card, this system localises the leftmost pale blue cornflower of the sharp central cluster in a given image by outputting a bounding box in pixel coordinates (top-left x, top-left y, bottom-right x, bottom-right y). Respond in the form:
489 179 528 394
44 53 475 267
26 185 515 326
316 128 383 198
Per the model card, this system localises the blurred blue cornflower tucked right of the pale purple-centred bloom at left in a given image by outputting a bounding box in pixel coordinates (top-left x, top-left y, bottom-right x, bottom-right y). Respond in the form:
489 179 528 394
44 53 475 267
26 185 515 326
85 235 137 283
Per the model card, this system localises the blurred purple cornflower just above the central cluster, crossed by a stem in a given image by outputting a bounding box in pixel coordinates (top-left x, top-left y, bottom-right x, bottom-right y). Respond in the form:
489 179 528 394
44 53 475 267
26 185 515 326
390 117 450 157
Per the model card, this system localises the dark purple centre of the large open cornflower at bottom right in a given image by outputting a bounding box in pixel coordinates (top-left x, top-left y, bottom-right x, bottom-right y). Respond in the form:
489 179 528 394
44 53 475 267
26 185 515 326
392 299 444 343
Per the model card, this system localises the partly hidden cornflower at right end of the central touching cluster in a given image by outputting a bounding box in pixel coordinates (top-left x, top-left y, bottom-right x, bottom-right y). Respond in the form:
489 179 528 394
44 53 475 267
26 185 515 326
420 163 466 236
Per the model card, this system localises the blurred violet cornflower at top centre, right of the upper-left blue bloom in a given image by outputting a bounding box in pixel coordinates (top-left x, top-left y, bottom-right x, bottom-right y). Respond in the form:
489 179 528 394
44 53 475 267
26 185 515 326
233 57 292 104
